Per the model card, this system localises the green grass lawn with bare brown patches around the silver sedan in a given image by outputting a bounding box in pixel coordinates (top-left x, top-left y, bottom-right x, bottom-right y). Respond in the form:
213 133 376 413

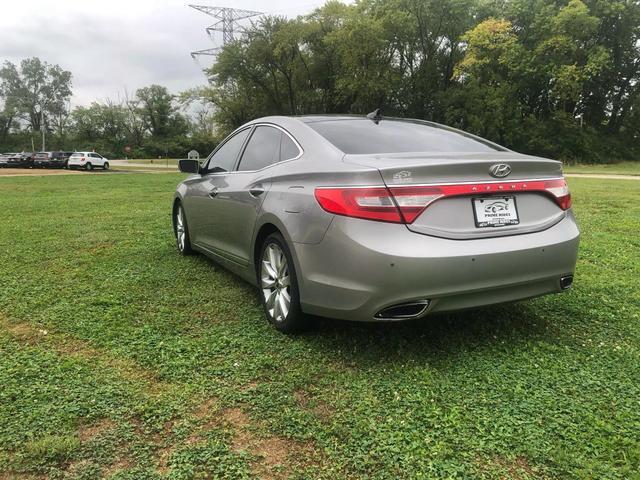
0 174 640 480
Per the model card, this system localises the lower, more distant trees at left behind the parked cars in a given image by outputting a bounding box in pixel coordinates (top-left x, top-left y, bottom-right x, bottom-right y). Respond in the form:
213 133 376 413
0 58 214 158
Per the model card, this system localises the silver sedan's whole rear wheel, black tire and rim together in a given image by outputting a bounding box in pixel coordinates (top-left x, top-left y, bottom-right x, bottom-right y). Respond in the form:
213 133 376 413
256 233 308 333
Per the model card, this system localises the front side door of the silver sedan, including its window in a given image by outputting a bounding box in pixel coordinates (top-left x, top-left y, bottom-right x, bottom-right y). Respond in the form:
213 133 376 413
183 127 251 255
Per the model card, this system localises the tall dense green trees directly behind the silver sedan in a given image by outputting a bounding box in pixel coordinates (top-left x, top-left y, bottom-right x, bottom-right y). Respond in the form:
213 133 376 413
190 0 640 162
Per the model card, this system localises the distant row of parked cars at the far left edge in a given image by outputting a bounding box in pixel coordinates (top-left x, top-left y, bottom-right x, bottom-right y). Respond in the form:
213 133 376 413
0 151 109 170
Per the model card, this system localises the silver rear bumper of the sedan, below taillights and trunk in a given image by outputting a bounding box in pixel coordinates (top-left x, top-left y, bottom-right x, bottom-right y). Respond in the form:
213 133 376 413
294 211 580 321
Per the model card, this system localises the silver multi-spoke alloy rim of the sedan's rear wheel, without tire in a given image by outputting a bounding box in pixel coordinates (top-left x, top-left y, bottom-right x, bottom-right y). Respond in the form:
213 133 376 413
260 243 291 322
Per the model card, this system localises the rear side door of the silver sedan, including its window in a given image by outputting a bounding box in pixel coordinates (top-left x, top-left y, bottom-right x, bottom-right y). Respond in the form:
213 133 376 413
209 124 293 264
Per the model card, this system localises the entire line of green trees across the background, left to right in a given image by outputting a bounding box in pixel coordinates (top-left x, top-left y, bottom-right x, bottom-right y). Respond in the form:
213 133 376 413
0 0 640 162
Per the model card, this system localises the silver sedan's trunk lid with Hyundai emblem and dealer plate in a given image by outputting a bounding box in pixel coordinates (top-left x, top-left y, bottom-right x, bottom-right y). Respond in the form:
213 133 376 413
345 151 566 240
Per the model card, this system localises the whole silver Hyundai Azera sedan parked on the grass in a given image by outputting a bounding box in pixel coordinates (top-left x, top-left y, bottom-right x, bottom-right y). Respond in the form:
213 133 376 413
173 112 579 332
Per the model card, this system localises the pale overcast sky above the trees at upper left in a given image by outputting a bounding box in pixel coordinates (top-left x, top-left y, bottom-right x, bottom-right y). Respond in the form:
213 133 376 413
0 0 324 106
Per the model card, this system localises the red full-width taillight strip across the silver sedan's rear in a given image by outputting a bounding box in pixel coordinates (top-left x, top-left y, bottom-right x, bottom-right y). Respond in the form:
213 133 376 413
315 178 571 223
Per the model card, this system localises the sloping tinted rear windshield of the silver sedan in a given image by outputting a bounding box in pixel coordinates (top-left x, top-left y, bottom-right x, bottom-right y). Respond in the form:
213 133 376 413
307 119 502 154
